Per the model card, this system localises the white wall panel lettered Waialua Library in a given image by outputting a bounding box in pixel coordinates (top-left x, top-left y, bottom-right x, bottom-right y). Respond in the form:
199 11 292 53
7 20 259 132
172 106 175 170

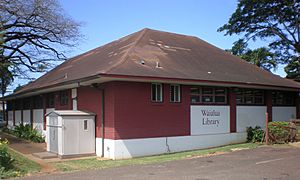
191 106 230 135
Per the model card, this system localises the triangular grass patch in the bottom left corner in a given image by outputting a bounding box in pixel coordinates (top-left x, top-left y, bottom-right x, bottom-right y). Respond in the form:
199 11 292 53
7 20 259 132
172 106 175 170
0 148 41 179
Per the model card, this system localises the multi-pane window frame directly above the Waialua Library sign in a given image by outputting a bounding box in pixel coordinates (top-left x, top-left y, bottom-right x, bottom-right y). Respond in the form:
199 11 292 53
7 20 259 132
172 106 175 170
190 86 228 105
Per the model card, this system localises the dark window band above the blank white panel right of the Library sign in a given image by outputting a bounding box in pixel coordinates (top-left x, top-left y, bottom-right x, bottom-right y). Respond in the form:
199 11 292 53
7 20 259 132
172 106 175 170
235 89 264 105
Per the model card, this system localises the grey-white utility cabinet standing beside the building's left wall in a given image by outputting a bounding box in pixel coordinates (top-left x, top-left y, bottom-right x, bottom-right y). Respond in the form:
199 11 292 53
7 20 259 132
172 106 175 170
46 110 95 158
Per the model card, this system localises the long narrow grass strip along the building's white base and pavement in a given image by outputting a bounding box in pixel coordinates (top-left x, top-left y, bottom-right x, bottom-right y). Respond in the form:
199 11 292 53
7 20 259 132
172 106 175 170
53 143 259 171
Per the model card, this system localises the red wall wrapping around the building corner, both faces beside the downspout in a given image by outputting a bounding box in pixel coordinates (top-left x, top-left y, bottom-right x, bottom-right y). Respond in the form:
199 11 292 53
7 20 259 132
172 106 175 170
77 82 190 139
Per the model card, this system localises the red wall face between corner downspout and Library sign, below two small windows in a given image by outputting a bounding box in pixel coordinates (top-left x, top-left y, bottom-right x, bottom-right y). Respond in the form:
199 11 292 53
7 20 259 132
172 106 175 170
113 82 190 139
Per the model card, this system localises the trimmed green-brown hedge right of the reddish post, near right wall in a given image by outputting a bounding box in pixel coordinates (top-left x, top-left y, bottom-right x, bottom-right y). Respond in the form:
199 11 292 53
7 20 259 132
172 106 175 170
268 122 289 143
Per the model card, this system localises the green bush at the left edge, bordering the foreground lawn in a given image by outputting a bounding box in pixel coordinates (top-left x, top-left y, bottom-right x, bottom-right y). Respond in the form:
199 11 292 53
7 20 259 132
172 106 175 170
0 138 14 171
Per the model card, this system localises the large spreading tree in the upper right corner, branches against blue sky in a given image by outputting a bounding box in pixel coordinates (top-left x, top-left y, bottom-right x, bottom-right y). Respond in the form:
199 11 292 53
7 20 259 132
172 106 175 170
218 0 300 77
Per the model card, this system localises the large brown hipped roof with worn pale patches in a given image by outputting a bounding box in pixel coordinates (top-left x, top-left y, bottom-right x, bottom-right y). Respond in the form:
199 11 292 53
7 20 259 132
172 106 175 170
11 29 300 94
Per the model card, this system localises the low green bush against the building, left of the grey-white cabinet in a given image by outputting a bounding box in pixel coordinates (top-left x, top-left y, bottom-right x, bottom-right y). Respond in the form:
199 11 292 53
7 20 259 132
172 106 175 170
11 124 45 143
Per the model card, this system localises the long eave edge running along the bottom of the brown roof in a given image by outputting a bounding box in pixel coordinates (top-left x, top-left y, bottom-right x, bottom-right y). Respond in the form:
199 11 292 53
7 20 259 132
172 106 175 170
0 74 300 100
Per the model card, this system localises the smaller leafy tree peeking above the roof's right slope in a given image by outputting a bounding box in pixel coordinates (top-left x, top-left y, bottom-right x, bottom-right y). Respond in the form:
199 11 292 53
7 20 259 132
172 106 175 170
226 39 279 71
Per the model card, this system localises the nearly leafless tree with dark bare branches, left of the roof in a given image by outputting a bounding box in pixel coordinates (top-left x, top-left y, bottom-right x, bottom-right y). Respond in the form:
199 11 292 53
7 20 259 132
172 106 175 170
0 0 81 76
